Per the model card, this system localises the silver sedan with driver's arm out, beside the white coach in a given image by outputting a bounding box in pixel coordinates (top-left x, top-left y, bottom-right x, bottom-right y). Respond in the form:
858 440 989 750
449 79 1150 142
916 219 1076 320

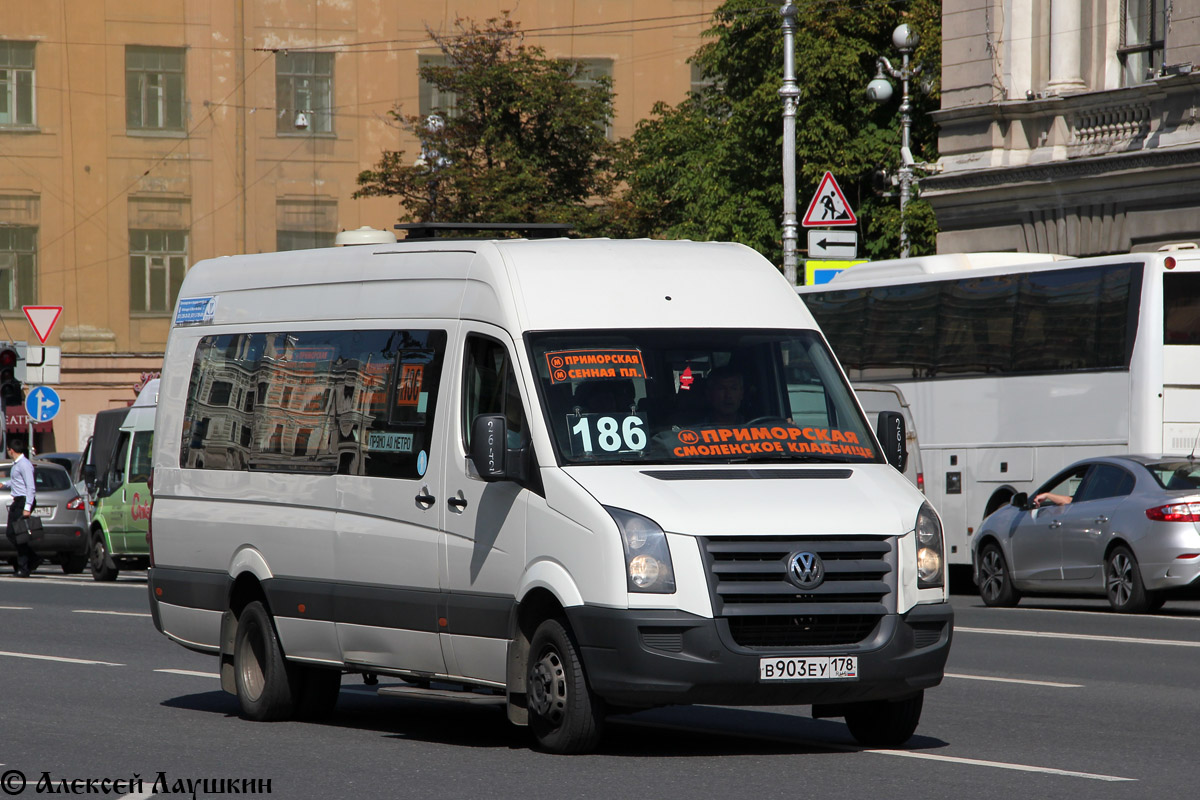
971 456 1200 613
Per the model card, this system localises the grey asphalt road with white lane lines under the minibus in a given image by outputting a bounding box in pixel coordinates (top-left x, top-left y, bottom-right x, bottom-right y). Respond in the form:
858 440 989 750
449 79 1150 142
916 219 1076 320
0 572 1200 800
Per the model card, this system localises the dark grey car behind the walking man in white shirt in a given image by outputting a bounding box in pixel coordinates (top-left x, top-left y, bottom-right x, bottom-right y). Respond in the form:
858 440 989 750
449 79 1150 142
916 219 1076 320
0 461 88 575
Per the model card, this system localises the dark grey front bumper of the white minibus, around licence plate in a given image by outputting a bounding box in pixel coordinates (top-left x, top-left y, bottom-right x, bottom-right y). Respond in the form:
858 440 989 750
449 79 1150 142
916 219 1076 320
566 603 954 706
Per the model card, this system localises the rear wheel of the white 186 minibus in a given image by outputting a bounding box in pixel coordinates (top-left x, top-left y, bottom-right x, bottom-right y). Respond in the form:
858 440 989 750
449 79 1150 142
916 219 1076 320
233 600 300 722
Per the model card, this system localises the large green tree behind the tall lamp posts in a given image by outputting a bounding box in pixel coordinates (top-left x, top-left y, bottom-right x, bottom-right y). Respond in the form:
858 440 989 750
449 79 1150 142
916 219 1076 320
608 0 941 264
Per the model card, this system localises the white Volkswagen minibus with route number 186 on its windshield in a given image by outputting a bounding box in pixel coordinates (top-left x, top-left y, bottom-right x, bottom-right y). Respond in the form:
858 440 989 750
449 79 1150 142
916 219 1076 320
149 239 953 752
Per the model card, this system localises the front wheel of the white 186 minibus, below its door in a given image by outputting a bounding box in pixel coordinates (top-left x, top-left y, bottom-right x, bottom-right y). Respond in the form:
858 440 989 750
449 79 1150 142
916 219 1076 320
526 619 604 753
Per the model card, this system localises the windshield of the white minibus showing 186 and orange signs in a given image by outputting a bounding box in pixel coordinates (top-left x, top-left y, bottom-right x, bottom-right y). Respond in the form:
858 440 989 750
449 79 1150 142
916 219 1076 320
529 329 882 464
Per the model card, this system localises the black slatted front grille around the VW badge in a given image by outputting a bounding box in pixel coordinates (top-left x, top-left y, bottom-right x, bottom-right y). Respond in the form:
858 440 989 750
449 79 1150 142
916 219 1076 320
701 536 895 649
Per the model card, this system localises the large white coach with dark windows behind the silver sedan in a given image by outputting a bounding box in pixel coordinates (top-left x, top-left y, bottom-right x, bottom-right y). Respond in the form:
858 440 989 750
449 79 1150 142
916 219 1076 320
798 249 1200 565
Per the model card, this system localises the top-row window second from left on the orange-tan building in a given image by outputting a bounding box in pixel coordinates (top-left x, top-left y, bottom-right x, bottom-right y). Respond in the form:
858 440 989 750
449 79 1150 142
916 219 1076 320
125 47 184 131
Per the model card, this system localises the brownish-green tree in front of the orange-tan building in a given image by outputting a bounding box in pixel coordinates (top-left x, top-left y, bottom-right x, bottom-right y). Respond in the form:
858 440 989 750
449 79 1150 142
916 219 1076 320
354 13 613 230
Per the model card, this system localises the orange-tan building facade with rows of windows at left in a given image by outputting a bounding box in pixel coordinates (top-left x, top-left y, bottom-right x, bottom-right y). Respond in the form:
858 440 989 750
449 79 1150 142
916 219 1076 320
0 0 719 452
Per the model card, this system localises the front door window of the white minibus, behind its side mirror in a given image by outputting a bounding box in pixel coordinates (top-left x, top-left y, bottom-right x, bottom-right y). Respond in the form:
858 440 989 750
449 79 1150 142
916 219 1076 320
462 336 528 452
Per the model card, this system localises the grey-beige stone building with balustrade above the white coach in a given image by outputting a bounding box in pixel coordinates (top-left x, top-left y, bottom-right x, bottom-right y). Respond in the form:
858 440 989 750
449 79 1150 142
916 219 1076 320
922 0 1200 255
